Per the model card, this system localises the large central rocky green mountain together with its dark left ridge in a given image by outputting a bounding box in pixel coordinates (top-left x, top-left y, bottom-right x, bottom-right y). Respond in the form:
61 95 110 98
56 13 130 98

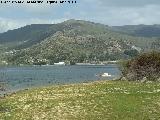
0 20 160 64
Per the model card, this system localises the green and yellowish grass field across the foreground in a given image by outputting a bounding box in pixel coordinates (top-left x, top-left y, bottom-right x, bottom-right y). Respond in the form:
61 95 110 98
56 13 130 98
0 81 160 120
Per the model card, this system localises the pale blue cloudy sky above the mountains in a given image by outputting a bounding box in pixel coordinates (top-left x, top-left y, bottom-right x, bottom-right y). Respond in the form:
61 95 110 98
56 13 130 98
0 0 160 33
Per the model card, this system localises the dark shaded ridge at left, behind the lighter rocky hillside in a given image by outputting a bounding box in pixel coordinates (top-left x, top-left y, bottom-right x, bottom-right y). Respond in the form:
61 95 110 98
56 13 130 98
0 20 110 49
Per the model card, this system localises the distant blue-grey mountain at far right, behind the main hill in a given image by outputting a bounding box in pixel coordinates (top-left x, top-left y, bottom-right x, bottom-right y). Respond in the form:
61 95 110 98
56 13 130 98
112 25 160 37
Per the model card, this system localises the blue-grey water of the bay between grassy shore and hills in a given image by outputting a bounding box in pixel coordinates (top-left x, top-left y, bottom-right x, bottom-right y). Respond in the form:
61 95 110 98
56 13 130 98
0 65 120 92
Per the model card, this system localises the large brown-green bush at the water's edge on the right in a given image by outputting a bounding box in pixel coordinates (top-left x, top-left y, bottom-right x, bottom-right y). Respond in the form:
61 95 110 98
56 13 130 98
121 51 160 81
